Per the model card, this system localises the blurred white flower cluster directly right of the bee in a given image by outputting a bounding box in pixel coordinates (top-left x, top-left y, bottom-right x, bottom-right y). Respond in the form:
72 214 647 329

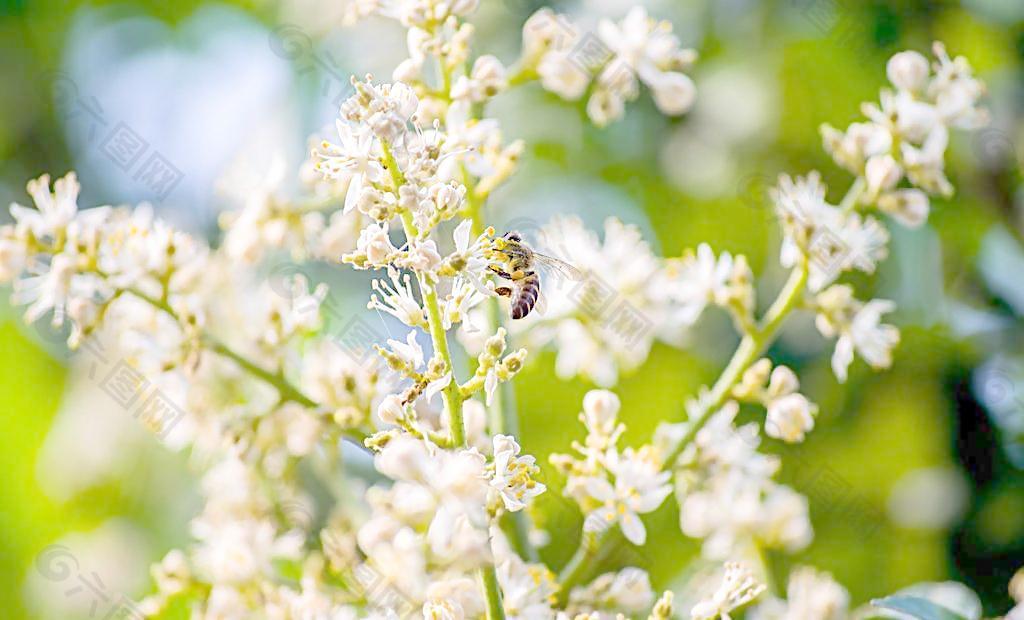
503 216 754 387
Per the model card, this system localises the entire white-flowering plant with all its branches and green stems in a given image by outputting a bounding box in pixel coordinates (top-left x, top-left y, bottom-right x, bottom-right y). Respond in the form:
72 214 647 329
0 0 983 620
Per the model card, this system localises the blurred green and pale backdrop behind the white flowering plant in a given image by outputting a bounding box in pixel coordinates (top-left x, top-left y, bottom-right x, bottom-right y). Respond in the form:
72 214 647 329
0 0 1024 618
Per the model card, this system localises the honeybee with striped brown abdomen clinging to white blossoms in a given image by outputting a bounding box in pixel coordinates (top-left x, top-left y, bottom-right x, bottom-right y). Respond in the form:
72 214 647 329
488 231 583 319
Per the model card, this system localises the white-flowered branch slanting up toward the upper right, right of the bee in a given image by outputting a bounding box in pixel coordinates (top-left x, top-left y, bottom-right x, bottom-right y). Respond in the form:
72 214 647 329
552 44 983 618
